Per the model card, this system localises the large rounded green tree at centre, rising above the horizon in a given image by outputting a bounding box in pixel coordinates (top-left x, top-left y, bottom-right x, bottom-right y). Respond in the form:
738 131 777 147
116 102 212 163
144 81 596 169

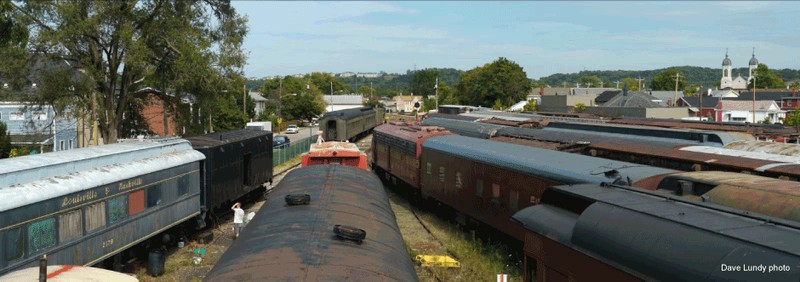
456 57 531 108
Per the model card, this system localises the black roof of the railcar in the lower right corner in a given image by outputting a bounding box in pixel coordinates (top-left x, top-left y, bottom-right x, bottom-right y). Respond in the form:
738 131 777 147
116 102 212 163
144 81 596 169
513 184 800 280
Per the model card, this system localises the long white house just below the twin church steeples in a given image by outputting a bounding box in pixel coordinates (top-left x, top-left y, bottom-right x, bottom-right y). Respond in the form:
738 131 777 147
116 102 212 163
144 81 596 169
714 100 786 123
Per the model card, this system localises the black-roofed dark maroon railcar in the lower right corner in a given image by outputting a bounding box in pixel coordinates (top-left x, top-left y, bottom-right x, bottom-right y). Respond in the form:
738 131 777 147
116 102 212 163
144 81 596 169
513 184 800 281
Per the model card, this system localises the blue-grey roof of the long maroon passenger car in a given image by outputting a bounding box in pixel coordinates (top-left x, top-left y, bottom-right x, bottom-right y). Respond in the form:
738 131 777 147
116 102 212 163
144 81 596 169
422 135 677 183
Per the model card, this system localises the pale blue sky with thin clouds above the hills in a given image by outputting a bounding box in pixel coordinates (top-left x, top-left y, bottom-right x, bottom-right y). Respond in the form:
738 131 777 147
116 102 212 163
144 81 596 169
233 1 800 79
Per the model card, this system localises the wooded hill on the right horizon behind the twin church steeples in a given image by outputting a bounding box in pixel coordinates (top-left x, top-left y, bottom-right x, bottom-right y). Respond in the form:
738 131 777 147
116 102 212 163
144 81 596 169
538 66 800 88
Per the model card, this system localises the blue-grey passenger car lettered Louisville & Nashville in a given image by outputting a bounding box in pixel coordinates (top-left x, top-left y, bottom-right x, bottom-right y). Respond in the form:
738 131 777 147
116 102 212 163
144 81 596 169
0 139 205 274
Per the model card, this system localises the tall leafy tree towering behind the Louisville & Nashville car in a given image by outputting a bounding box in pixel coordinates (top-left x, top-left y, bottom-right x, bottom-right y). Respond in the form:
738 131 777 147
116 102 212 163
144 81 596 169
10 0 247 143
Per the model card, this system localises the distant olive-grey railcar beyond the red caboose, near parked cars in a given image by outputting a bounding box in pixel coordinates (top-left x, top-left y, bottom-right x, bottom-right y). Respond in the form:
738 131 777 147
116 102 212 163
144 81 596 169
319 107 384 141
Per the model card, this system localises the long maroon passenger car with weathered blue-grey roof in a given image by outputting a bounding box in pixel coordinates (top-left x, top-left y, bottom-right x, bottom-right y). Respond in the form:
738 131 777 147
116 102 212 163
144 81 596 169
416 135 677 240
